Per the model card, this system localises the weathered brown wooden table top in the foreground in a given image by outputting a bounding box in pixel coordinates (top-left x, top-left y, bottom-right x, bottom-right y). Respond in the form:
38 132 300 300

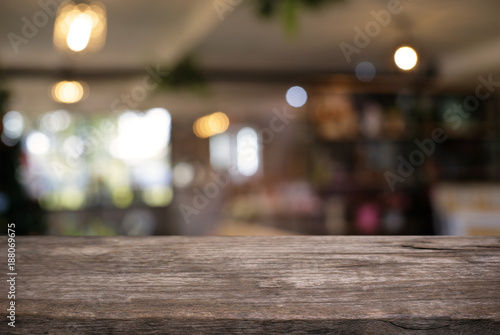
0 236 500 335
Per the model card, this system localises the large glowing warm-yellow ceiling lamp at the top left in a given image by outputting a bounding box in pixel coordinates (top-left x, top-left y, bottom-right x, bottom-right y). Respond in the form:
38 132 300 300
54 1 106 52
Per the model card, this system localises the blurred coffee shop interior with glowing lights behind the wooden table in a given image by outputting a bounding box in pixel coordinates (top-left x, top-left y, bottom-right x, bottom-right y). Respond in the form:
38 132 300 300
0 0 500 235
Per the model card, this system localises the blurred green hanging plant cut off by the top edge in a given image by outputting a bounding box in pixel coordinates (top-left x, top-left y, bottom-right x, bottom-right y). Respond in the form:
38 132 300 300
257 0 344 35
